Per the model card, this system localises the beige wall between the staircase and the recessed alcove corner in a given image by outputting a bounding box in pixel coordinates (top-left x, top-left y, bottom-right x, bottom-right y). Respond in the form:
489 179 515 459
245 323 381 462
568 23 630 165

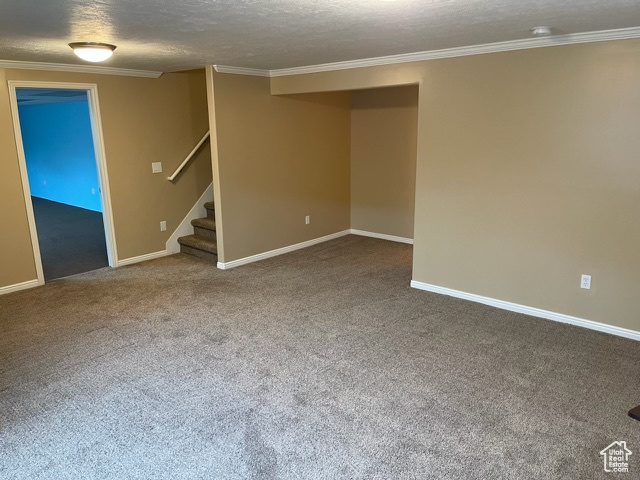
213 73 350 262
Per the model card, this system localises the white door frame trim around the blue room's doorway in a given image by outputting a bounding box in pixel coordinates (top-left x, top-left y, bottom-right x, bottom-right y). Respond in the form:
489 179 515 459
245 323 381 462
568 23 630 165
7 80 118 285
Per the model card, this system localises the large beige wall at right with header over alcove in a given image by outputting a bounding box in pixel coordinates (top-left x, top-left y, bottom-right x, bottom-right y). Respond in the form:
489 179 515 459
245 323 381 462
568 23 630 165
272 40 640 331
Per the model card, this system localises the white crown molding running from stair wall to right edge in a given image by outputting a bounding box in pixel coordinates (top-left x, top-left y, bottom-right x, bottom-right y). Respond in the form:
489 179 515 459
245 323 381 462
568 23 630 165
214 27 640 77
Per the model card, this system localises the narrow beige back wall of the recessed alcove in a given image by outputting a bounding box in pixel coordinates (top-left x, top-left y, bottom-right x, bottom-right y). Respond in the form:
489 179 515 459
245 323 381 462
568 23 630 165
351 86 418 238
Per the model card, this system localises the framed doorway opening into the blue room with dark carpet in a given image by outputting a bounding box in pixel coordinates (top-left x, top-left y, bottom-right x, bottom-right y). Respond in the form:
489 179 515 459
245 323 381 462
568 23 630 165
10 82 115 284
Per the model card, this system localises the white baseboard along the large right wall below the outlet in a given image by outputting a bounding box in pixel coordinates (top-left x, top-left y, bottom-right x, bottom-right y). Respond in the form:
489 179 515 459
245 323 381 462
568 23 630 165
411 280 640 340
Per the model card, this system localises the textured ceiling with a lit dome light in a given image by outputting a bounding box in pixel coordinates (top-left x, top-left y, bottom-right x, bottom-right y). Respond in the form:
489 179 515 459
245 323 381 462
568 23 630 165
0 0 640 71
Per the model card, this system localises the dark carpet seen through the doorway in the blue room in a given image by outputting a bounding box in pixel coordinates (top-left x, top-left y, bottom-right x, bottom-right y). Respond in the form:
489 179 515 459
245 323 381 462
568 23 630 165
31 197 109 280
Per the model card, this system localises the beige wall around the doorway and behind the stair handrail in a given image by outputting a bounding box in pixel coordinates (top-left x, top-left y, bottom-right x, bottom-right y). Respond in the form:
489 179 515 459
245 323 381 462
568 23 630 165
0 66 211 286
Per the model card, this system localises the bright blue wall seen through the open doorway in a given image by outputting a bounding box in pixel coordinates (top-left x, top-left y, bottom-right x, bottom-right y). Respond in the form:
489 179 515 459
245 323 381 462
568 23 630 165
18 96 102 212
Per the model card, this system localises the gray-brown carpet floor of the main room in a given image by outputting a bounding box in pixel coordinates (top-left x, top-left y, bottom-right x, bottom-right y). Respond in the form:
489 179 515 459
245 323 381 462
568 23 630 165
0 236 640 480
